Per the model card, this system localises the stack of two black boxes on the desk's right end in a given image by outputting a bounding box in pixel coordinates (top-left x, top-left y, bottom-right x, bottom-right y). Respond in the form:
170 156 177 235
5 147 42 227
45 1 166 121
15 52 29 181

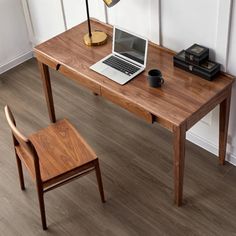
174 44 220 80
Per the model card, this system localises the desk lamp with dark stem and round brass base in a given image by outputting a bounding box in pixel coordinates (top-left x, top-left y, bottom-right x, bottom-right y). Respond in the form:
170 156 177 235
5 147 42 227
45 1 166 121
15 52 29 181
84 0 120 46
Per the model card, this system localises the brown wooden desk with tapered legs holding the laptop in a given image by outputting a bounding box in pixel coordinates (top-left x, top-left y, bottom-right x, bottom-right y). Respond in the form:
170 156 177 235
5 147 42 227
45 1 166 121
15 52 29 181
34 20 234 205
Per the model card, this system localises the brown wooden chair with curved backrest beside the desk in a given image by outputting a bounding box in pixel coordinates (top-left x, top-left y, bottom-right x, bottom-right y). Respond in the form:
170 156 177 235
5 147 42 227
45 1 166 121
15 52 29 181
5 106 105 230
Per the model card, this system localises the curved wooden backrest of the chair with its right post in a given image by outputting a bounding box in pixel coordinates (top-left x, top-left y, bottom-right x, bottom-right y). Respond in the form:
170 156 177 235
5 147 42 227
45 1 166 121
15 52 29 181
4 105 41 179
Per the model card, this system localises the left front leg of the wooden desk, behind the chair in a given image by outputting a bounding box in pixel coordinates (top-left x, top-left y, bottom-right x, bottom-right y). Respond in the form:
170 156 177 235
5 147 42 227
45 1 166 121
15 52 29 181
38 62 56 123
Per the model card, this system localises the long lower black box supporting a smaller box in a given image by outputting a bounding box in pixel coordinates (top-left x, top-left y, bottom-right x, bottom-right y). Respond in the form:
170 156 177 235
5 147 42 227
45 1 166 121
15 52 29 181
174 50 220 80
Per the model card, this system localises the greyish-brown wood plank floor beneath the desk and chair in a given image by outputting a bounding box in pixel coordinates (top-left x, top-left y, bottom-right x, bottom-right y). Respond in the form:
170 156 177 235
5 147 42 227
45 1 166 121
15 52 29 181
0 59 236 236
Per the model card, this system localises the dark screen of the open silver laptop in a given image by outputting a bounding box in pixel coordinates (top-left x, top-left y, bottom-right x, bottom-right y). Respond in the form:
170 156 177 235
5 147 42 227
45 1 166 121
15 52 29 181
113 28 146 65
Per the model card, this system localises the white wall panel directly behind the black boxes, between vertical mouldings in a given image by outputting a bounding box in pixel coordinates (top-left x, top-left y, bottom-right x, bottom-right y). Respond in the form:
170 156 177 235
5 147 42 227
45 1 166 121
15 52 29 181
161 0 218 54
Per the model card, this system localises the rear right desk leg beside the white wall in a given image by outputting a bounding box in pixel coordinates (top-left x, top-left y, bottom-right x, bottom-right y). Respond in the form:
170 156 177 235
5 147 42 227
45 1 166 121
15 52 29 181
219 90 231 165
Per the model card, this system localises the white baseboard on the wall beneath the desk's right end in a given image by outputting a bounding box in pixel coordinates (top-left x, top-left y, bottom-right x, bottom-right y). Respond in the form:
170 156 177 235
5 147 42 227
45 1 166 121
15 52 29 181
186 131 236 166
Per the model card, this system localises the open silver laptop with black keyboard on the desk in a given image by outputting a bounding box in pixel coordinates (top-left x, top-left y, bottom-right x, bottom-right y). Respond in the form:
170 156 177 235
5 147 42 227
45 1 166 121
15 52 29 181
90 27 148 85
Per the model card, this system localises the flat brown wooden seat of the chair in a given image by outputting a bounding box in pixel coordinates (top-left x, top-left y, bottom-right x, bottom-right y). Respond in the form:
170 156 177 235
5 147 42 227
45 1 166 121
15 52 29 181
16 119 97 182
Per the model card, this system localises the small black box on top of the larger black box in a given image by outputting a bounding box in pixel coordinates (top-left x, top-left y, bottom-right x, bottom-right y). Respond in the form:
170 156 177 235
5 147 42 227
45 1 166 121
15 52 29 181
185 44 209 65
